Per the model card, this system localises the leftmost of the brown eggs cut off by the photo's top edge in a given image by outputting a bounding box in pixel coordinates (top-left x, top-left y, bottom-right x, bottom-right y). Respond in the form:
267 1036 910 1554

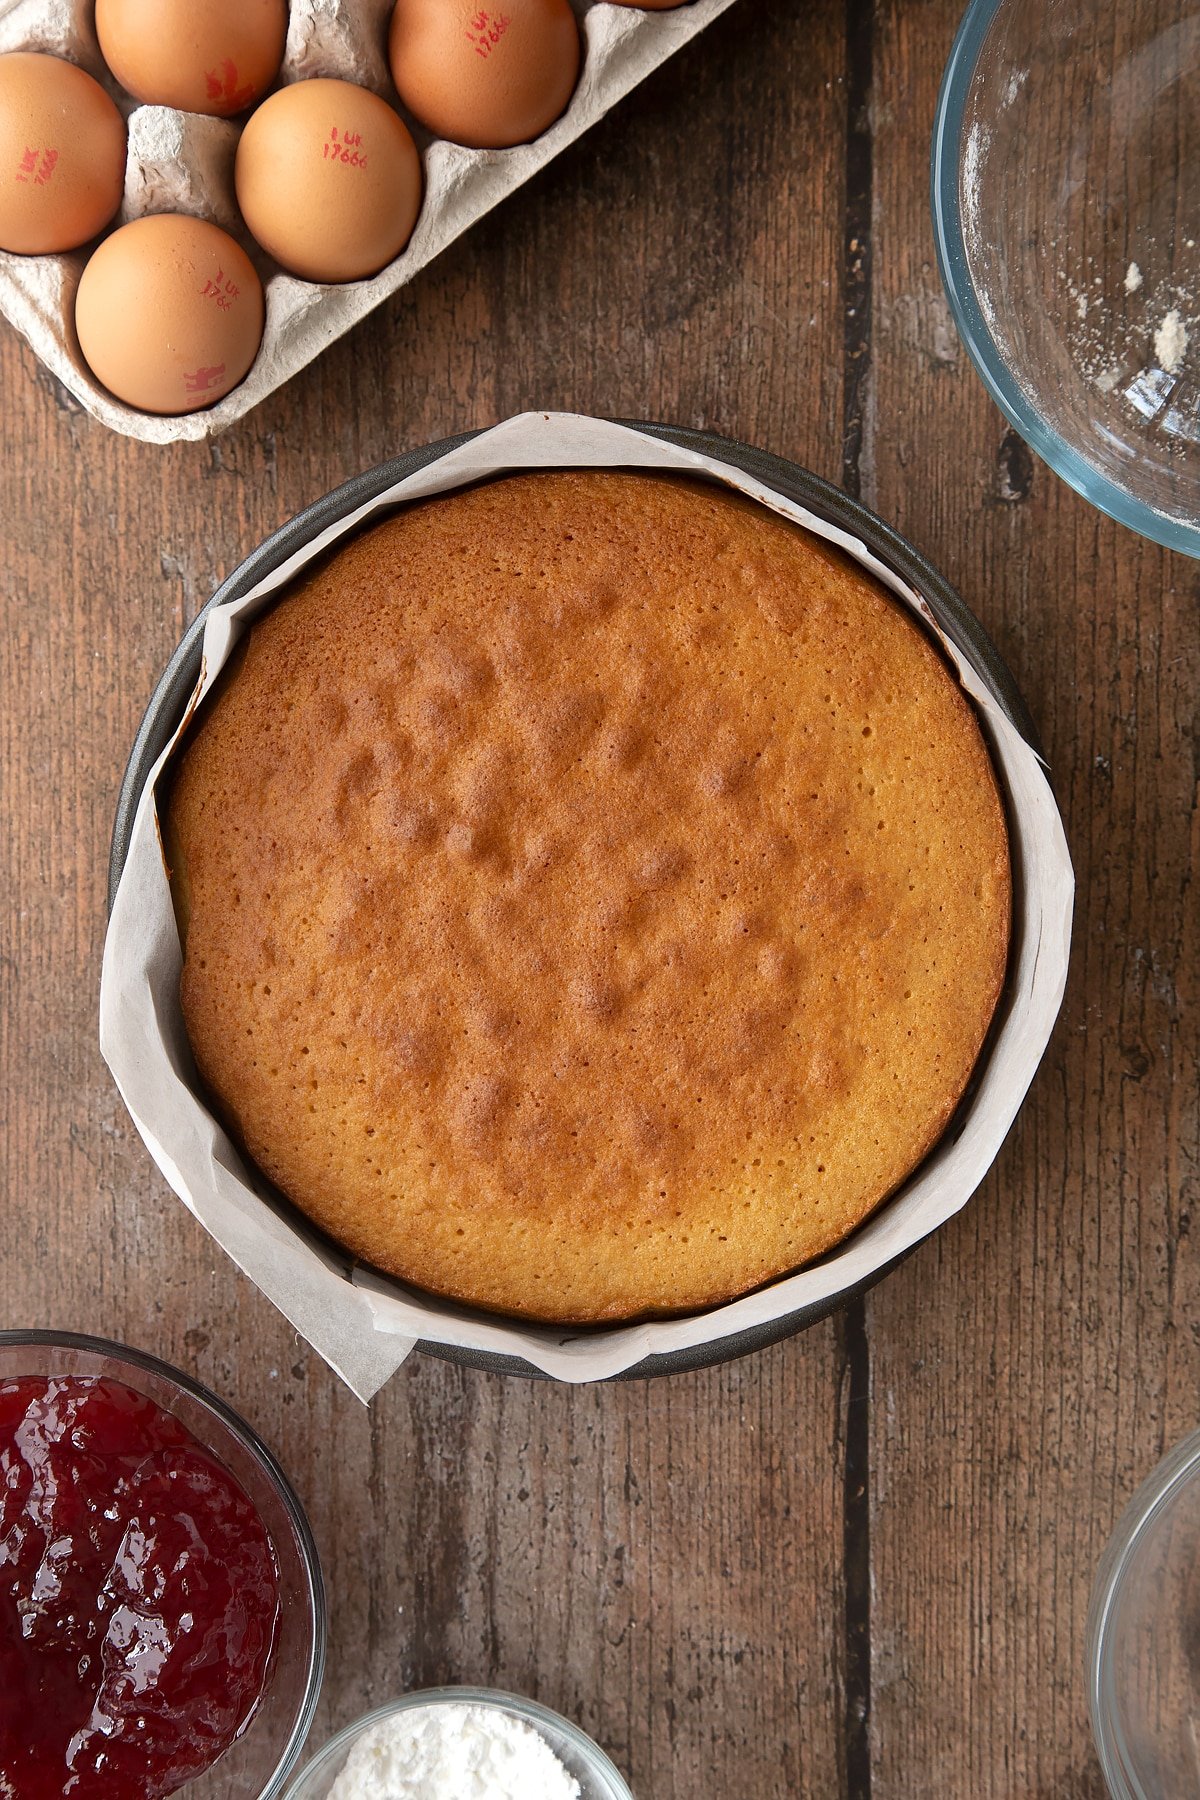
95 0 288 119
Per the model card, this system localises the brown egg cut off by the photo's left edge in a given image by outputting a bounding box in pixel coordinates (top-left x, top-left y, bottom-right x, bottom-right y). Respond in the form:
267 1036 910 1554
0 50 126 256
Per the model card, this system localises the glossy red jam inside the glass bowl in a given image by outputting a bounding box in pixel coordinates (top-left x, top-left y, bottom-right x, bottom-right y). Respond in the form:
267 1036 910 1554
0 1377 279 1800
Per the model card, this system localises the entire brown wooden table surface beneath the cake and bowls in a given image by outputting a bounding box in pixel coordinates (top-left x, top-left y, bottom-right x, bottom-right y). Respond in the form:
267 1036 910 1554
0 0 1200 1800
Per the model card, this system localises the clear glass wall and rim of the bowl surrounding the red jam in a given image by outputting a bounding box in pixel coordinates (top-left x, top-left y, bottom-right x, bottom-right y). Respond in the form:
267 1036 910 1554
0 1330 326 1800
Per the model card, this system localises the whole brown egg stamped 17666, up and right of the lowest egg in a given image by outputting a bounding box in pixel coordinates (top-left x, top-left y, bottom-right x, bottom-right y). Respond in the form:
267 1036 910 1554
236 79 421 281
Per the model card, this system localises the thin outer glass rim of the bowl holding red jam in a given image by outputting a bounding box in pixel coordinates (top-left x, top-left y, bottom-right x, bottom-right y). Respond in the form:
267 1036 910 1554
0 1328 327 1800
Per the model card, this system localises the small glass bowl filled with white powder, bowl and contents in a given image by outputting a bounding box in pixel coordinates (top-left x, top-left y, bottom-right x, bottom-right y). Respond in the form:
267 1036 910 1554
286 1688 633 1800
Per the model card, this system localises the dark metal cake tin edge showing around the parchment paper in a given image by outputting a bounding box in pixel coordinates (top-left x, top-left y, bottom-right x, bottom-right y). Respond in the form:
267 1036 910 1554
108 421 1038 1381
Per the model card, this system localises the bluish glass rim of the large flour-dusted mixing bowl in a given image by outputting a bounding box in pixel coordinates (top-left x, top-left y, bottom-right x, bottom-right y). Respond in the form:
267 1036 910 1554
930 0 1200 556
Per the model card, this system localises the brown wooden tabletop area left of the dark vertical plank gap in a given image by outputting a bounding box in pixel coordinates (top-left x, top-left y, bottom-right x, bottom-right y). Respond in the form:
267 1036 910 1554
0 0 844 1800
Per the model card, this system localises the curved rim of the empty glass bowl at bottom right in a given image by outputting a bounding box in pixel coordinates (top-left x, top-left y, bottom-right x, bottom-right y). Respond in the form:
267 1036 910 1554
1085 1429 1200 1800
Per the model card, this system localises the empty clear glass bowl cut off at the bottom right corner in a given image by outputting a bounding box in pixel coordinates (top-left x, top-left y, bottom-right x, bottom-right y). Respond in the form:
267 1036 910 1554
1085 1431 1200 1800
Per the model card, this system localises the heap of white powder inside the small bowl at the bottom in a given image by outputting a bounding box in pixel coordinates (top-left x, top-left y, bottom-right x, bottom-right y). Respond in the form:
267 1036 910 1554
329 1705 579 1800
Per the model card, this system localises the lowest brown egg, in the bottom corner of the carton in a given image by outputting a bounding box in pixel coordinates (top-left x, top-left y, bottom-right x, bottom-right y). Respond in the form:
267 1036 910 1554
76 212 263 412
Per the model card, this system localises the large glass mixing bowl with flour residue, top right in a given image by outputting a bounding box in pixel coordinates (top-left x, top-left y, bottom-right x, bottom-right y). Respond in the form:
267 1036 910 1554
934 0 1200 556
